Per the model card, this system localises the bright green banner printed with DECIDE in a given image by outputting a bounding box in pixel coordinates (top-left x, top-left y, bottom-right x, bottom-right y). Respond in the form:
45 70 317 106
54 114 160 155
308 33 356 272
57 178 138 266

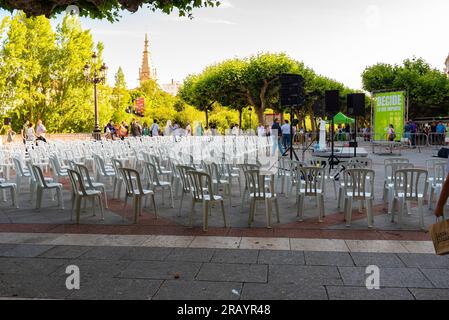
374 92 405 141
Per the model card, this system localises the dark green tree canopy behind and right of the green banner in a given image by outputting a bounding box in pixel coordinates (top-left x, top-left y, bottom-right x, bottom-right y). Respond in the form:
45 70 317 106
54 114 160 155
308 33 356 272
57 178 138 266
362 58 449 118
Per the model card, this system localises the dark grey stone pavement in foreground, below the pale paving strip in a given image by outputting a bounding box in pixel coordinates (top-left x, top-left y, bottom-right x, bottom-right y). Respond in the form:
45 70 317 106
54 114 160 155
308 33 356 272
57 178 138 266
0 244 449 300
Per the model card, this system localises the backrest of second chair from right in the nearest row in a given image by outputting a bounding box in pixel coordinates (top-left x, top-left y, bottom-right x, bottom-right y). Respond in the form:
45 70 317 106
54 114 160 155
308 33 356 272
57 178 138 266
343 169 375 200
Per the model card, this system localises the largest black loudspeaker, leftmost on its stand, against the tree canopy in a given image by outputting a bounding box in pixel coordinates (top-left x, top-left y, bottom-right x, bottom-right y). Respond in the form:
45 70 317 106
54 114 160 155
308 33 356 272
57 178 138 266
279 74 305 108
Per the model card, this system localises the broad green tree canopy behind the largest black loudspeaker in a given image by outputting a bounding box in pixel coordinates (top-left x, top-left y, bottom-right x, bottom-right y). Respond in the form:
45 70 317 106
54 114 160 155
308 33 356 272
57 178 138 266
180 53 353 129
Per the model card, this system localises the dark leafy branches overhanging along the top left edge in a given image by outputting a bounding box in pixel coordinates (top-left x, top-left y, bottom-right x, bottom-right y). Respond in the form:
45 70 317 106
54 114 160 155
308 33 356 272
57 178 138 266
0 0 220 22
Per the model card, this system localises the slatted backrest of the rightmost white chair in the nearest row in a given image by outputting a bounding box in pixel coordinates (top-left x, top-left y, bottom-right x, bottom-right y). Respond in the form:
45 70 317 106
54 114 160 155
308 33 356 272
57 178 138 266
394 169 429 200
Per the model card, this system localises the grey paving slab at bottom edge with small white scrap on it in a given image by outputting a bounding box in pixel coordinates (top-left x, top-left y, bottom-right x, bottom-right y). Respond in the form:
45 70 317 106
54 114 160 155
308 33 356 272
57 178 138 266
153 280 242 300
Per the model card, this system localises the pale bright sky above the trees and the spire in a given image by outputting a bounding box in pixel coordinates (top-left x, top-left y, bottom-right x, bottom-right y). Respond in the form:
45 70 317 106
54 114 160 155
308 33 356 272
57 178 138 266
3 0 449 89
